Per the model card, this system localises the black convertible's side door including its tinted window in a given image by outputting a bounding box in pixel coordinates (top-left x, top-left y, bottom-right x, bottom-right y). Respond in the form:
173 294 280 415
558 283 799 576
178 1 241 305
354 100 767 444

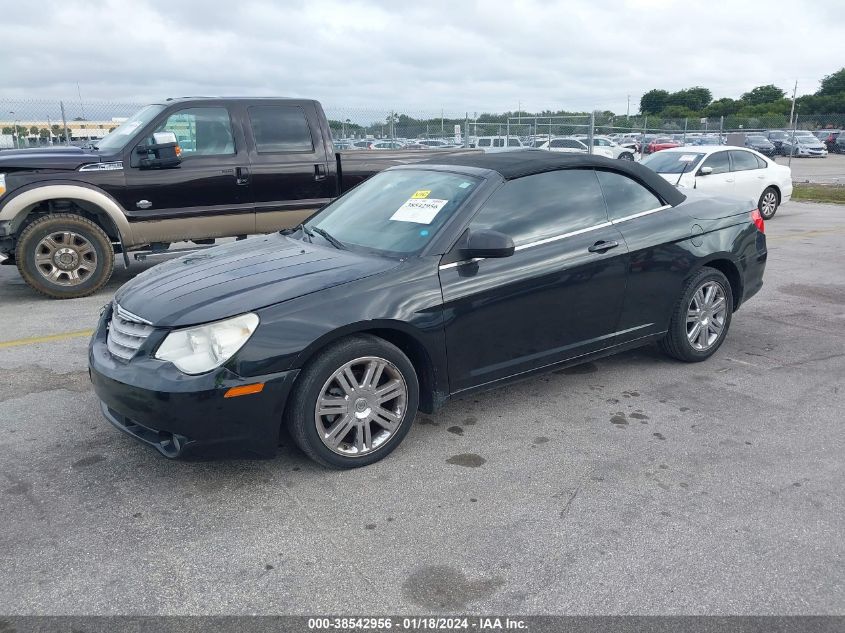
440 169 628 392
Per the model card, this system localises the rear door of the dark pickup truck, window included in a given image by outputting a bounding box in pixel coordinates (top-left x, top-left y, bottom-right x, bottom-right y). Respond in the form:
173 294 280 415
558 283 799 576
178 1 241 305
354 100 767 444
244 102 338 233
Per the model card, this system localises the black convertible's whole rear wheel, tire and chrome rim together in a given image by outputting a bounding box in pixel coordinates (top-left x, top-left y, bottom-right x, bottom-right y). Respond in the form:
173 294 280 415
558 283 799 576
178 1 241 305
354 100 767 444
658 267 734 363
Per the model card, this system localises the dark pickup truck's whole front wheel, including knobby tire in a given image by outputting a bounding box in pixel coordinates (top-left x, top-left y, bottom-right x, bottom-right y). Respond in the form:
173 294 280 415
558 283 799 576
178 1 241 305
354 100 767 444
15 213 114 299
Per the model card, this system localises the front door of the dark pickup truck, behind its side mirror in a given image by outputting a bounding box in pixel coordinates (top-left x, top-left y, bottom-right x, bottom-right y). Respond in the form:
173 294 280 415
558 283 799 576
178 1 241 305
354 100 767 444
115 105 255 228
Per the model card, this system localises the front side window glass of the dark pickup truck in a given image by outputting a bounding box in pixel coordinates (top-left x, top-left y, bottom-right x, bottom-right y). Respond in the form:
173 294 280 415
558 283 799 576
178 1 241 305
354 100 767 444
155 106 235 158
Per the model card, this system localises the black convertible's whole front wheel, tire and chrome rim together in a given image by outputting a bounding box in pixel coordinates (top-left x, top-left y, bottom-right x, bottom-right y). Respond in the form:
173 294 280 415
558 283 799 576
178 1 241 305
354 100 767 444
285 334 419 469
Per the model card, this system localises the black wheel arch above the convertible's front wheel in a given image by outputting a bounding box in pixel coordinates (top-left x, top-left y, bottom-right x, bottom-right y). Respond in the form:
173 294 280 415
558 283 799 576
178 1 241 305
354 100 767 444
296 319 448 413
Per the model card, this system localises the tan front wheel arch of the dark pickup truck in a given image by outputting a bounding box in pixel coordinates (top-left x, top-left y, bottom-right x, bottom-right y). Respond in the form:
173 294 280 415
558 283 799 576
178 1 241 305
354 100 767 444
0 183 132 244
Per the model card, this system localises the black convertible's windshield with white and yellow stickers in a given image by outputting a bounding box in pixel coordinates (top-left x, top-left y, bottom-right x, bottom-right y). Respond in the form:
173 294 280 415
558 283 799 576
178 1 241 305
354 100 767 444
305 169 479 256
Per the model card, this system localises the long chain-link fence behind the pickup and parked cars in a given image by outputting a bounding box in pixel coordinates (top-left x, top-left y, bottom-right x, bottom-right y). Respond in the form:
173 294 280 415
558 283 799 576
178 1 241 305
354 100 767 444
0 98 845 149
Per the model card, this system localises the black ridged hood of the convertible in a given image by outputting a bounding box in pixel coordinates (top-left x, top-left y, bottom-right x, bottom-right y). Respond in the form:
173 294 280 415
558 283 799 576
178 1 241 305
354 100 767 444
115 233 399 327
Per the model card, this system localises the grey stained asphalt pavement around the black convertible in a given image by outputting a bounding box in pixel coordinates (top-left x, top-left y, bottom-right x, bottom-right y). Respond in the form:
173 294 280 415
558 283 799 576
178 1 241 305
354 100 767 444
0 201 845 615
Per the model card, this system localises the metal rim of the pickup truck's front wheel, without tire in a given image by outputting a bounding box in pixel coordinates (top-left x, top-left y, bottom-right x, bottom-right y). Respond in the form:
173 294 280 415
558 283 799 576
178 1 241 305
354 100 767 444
35 231 97 286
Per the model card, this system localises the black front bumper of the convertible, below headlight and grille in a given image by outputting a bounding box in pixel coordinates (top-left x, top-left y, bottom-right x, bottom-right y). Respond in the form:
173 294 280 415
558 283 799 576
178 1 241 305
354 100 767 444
88 310 299 458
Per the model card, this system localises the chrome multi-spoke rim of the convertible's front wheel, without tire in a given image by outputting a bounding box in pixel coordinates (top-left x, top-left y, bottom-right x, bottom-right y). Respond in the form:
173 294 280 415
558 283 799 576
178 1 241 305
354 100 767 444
314 356 408 457
